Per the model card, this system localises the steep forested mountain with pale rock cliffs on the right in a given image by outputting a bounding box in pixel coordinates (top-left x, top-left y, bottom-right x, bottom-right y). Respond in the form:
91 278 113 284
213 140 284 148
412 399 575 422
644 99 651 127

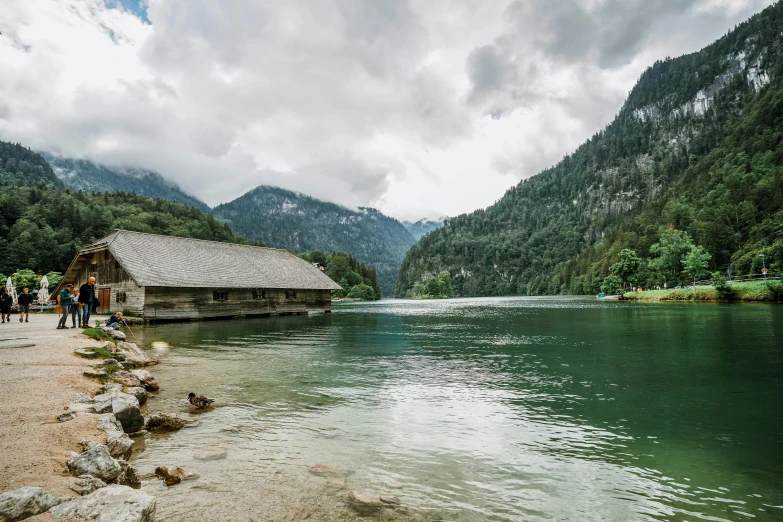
396 2 783 295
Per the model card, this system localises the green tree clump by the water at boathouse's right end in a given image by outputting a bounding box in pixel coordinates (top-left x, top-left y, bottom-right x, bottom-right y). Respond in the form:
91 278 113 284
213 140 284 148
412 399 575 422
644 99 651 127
299 250 381 301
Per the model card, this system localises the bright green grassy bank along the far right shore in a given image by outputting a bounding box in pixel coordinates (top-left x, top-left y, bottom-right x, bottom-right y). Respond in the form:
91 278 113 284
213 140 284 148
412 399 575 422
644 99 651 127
623 281 783 301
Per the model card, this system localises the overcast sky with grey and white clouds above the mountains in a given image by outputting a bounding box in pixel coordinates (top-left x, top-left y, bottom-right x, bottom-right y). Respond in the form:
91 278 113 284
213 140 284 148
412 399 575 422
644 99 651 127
0 0 772 219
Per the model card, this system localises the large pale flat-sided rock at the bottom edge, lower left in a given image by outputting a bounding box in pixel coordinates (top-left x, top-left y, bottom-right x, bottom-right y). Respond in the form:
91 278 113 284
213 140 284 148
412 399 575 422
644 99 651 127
49 484 156 522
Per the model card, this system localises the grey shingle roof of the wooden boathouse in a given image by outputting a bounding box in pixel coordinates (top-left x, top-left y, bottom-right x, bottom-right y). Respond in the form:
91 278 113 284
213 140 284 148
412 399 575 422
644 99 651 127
85 230 341 290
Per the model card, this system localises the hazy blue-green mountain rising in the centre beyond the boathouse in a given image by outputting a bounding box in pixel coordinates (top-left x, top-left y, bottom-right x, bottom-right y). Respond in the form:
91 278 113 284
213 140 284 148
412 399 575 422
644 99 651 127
213 185 416 296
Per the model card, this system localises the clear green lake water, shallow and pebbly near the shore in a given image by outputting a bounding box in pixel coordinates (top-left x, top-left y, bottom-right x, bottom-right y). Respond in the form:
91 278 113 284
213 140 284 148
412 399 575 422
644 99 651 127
132 298 783 521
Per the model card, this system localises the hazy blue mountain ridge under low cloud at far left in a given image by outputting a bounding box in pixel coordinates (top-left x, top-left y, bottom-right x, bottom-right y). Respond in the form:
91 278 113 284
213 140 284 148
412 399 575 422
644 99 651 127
42 153 209 212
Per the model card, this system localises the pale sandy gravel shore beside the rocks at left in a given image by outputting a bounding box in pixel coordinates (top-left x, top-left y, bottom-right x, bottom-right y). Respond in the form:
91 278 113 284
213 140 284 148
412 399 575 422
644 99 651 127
0 314 113 496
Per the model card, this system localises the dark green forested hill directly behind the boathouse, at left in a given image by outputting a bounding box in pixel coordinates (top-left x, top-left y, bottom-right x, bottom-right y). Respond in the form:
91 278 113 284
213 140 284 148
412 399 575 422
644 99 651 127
0 182 246 274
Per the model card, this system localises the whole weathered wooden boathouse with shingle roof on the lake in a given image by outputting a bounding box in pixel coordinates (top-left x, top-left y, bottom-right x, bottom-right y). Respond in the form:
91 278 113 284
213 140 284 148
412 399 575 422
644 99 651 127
54 230 341 322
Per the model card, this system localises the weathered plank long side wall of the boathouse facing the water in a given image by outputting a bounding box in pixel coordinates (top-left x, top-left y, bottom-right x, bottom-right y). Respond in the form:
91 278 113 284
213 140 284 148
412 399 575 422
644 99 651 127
144 287 332 321
